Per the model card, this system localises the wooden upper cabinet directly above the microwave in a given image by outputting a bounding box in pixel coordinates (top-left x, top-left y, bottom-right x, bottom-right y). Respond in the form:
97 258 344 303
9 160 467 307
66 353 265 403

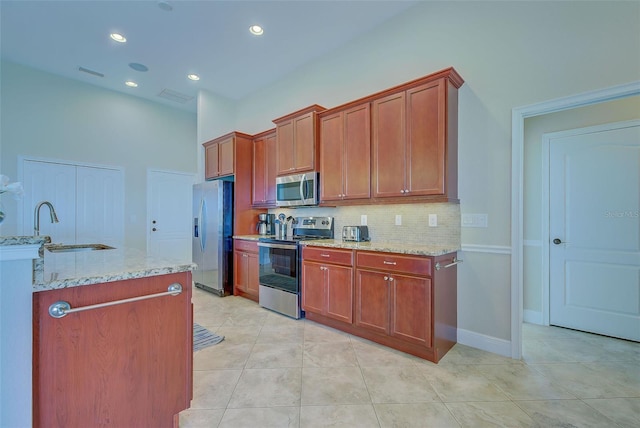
273 105 324 175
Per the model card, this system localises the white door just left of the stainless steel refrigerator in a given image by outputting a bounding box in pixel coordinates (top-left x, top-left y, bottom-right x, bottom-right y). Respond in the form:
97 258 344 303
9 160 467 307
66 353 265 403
147 170 195 263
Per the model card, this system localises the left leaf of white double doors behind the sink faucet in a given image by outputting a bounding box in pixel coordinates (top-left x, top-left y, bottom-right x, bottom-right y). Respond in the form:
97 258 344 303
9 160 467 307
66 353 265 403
22 159 76 244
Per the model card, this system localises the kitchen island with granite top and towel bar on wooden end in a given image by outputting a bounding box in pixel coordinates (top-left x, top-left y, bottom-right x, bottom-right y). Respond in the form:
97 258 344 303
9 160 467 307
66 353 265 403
33 242 195 427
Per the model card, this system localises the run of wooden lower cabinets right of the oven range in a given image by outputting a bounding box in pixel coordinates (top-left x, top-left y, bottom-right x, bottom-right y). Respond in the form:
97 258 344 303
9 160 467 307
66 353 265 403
302 246 457 362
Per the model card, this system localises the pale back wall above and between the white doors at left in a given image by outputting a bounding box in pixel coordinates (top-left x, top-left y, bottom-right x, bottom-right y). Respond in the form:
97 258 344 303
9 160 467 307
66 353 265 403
0 62 197 249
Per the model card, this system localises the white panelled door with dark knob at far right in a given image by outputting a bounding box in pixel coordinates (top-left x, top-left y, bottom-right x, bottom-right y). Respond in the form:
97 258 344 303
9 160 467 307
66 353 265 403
548 121 640 341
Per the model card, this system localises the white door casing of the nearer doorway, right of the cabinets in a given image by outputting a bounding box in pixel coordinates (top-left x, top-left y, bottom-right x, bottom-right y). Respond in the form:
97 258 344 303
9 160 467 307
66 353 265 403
511 81 640 359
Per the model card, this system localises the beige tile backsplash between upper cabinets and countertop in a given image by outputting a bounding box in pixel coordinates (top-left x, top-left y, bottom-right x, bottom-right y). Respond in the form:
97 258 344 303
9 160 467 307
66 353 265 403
269 203 460 247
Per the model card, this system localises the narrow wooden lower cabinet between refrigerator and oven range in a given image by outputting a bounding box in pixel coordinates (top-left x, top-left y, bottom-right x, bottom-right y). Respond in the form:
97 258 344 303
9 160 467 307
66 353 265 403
233 240 260 302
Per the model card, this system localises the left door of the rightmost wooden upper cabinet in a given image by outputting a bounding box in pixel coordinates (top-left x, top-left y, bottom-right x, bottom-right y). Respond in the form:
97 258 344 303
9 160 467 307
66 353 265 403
372 92 406 197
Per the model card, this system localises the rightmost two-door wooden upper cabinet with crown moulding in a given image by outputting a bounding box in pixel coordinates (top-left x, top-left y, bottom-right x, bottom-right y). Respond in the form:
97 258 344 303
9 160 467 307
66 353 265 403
371 68 463 200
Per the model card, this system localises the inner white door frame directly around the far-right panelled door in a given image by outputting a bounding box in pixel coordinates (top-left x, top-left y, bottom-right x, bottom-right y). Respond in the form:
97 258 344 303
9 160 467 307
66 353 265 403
541 119 640 325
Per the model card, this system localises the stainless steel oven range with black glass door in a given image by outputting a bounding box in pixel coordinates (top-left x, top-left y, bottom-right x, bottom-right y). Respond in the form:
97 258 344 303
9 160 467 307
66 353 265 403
258 217 333 319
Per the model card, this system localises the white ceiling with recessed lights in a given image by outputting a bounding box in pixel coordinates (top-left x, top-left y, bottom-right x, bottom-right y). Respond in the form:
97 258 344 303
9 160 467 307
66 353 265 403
0 0 417 112
